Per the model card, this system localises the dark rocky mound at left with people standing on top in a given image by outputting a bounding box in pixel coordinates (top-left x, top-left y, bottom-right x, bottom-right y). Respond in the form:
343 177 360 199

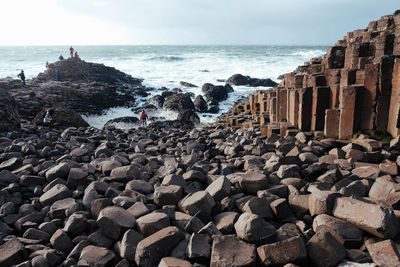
0 58 145 120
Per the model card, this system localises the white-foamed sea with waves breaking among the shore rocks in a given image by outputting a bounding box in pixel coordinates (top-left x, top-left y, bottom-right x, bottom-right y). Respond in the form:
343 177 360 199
0 45 328 128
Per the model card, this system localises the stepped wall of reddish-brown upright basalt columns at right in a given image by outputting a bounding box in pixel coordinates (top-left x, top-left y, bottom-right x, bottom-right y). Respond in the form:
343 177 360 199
226 9 400 139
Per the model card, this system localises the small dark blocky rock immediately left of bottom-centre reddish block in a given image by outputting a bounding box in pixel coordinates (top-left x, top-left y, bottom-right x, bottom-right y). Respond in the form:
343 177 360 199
186 233 211 260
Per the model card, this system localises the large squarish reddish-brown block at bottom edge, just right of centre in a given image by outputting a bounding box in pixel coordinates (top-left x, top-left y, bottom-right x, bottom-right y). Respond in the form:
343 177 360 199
210 235 257 267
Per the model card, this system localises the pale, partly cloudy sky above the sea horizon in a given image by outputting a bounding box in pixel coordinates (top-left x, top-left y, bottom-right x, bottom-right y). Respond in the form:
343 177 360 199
0 0 400 45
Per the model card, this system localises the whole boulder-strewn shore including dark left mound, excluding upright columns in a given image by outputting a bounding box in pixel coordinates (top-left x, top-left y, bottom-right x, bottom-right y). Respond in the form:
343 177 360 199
0 9 400 267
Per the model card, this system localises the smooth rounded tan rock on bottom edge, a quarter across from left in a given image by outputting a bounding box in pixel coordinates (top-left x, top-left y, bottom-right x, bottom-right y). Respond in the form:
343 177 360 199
78 245 115 267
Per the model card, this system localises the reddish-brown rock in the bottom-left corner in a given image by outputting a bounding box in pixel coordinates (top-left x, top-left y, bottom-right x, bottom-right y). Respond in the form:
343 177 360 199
0 238 28 267
